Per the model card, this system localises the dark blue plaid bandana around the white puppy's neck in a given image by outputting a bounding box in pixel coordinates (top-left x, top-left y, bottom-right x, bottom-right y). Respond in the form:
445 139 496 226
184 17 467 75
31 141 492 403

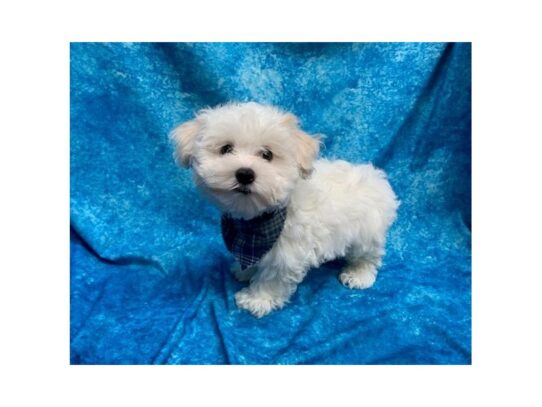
221 208 286 269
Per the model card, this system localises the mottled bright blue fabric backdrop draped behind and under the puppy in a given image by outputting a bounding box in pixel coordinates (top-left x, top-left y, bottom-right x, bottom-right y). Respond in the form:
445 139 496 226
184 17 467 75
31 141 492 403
70 43 471 364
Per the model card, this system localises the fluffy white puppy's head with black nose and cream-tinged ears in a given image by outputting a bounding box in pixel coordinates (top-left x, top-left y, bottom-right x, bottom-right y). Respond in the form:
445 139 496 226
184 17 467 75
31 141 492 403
171 103 319 219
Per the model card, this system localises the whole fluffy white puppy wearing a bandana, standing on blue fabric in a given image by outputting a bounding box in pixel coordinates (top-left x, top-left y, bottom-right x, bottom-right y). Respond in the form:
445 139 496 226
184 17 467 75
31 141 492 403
171 103 399 317
